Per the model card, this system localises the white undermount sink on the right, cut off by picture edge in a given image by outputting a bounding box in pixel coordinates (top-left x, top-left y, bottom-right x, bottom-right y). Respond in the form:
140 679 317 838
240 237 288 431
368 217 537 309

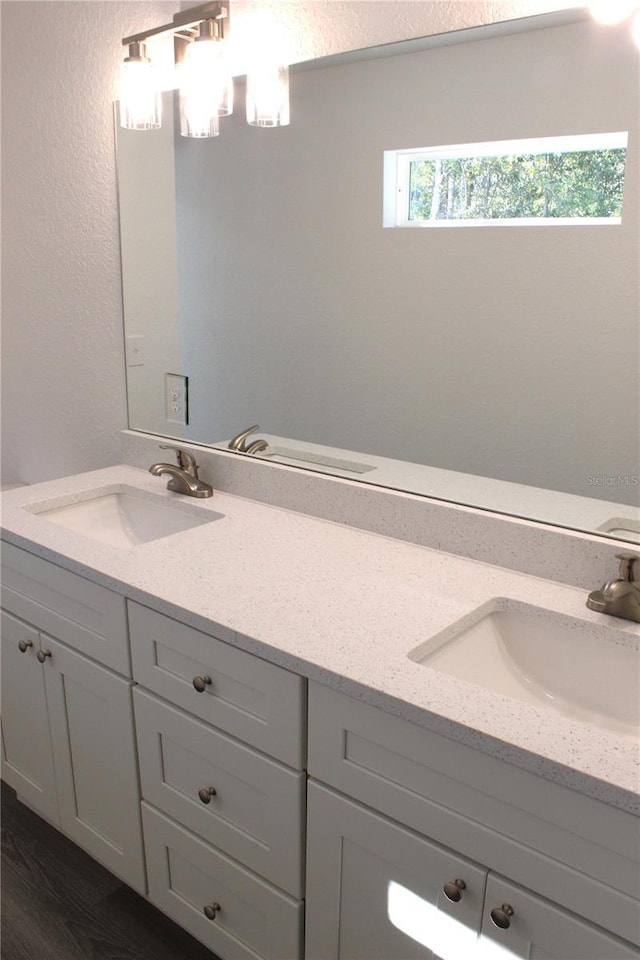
409 599 640 737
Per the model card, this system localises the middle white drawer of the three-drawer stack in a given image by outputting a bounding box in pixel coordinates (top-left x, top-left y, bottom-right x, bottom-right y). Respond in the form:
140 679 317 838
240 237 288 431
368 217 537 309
134 688 306 897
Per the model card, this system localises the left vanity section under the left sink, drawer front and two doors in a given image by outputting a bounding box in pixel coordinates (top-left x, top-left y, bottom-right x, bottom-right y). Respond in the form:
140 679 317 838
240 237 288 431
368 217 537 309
2 545 146 892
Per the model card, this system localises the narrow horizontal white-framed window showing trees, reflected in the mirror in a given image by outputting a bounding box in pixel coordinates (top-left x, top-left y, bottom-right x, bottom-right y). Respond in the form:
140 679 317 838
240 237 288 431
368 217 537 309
383 133 627 227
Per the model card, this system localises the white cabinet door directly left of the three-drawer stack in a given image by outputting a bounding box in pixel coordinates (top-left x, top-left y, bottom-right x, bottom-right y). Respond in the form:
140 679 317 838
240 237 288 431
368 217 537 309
41 634 145 891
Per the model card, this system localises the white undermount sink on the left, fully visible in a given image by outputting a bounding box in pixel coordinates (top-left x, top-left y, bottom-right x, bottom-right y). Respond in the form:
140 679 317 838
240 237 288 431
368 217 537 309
27 486 223 547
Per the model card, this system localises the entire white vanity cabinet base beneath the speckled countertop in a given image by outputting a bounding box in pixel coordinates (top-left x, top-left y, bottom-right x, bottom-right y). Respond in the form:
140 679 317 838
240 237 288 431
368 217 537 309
2 544 640 960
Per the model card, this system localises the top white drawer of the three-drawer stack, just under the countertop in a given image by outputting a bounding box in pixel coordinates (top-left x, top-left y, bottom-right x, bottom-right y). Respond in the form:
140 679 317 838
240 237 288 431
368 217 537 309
129 602 306 769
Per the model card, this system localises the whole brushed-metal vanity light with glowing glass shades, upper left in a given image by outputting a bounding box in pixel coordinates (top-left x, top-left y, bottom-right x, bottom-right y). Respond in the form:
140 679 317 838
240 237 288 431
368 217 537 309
120 0 289 139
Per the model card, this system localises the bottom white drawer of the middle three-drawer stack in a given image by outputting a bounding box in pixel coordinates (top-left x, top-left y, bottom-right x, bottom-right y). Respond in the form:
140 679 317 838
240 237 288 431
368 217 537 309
142 801 303 960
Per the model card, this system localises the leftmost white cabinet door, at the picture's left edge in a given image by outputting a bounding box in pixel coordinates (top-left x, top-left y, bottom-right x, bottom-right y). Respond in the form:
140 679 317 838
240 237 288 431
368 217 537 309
2 611 59 825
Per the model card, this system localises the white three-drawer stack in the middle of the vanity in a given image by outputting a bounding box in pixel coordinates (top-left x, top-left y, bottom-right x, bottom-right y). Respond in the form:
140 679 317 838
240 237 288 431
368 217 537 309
129 602 306 960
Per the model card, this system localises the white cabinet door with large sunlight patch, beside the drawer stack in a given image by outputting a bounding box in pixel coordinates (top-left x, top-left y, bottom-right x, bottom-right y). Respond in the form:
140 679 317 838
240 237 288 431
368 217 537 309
306 782 486 960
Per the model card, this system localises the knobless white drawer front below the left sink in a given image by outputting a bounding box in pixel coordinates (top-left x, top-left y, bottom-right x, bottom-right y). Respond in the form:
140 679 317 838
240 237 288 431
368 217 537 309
2 543 131 677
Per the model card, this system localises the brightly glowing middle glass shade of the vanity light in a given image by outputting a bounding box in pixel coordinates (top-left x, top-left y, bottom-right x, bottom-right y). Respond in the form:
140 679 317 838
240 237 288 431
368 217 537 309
178 37 233 138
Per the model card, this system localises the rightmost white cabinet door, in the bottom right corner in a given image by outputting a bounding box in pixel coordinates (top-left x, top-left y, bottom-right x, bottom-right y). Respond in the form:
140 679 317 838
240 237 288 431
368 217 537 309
479 873 640 960
